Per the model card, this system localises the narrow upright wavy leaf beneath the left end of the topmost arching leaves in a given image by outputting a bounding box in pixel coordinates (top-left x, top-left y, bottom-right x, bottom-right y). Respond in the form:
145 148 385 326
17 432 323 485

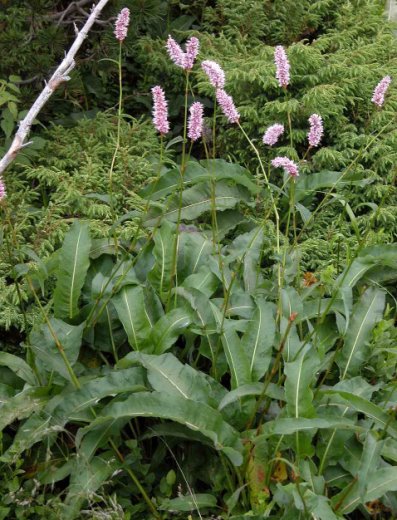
148 220 176 301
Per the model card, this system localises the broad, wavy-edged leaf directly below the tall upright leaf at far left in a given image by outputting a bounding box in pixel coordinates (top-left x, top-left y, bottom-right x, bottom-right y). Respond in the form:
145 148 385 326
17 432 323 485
29 318 85 381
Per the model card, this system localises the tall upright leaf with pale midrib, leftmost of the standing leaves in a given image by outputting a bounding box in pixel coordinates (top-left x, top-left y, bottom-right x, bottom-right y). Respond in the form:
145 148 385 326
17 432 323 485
54 220 91 319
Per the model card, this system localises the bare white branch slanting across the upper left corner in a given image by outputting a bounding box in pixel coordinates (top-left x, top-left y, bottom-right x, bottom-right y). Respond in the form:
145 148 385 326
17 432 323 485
0 0 109 176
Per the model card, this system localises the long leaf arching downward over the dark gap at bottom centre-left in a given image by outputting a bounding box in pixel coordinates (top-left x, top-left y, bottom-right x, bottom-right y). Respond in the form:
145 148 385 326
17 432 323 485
76 392 243 466
